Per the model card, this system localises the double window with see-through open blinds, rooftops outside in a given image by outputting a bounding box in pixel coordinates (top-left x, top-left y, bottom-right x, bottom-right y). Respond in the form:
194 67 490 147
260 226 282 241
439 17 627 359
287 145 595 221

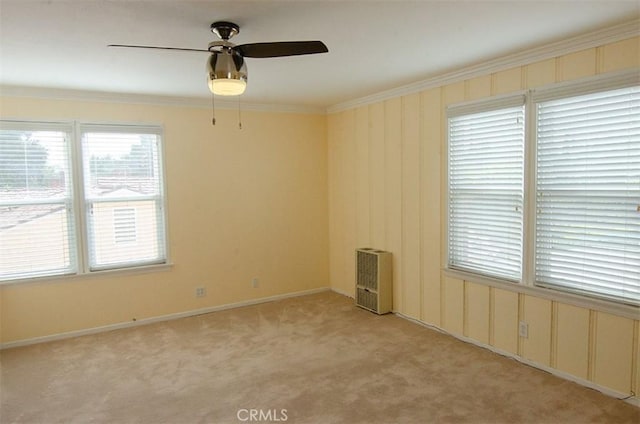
0 121 167 281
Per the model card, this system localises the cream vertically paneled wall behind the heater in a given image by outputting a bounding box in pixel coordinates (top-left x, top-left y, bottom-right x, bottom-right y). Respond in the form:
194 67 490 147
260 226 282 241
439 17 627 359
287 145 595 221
328 38 640 394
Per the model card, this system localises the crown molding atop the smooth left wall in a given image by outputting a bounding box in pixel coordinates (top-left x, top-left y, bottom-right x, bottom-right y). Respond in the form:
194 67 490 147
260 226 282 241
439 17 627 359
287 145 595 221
0 85 326 115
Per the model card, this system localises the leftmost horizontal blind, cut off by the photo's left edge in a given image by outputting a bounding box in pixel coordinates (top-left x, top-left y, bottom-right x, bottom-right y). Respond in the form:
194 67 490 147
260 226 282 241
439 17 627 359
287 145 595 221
0 121 77 280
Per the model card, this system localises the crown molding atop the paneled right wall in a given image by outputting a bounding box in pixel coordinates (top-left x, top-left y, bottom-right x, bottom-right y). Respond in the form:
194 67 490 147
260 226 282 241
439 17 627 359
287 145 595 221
326 19 640 114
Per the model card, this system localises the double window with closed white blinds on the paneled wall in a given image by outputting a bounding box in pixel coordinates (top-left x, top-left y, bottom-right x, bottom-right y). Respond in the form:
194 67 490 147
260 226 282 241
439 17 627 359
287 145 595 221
448 73 640 304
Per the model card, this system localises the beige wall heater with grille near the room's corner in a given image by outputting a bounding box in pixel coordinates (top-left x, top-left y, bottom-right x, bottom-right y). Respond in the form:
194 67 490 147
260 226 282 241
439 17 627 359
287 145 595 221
356 248 393 314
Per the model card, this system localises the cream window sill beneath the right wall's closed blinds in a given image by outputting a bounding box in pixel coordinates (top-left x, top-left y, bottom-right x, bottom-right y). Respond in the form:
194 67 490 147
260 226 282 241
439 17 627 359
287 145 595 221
442 268 640 320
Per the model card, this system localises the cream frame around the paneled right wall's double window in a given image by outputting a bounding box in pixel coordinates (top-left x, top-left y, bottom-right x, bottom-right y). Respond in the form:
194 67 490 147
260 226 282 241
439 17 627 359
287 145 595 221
442 69 640 319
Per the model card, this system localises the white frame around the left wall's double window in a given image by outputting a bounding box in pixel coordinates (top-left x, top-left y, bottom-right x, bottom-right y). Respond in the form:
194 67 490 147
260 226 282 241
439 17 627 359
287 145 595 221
0 118 172 286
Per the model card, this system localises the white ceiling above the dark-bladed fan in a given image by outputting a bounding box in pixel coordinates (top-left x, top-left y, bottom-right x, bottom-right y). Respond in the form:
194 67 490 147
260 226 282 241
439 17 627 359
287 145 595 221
0 0 640 108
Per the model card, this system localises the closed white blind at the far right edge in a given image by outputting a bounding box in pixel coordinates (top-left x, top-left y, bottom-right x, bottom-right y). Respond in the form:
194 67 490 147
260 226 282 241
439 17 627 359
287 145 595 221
535 87 640 303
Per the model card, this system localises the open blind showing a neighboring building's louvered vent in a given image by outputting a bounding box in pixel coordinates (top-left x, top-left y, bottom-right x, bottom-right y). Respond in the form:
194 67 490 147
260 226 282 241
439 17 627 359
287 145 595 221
82 126 166 270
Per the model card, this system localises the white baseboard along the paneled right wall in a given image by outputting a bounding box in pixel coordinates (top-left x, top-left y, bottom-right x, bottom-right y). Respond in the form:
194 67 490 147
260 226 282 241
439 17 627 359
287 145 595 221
394 312 640 407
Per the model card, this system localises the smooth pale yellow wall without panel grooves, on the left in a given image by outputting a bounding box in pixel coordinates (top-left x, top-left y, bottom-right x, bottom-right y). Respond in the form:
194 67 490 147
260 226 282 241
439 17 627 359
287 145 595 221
0 98 329 343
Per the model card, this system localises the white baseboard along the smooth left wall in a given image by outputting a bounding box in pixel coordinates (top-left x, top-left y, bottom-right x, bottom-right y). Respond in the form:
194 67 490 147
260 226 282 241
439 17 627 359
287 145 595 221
0 287 330 350
